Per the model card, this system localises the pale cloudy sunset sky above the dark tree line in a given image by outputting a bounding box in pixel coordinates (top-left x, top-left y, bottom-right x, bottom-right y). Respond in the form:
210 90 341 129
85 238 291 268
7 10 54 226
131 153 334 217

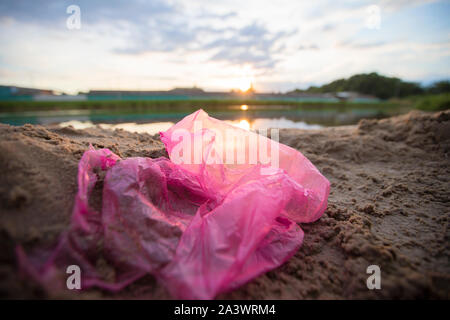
0 0 450 93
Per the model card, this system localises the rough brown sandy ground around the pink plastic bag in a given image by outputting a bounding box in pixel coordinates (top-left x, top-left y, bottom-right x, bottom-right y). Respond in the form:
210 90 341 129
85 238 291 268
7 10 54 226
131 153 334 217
0 111 450 299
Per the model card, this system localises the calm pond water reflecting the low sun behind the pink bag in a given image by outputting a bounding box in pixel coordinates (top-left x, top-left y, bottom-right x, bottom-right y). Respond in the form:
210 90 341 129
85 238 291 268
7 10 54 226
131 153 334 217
0 105 386 134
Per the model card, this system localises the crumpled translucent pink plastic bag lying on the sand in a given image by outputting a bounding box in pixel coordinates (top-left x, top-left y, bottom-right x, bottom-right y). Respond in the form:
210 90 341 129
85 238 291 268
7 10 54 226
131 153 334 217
17 110 329 299
